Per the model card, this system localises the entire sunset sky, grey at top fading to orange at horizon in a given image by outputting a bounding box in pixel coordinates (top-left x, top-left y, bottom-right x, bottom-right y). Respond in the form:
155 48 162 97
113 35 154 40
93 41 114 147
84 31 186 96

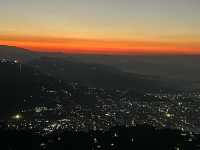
0 0 200 54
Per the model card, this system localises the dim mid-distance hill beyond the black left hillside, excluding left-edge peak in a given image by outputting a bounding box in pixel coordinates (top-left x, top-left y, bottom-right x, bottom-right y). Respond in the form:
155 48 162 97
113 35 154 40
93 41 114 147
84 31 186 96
28 57 164 90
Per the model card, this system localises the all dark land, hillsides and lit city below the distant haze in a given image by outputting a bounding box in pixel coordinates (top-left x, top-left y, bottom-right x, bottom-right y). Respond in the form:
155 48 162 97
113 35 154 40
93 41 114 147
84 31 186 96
0 47 200 150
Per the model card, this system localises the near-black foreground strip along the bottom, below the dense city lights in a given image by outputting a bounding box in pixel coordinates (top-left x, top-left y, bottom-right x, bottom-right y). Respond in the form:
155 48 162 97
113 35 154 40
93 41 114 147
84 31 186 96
0 126 200 150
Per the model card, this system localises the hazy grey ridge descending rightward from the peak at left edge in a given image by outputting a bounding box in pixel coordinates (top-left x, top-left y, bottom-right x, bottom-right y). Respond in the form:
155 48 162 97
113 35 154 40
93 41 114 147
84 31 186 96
0 46 166 89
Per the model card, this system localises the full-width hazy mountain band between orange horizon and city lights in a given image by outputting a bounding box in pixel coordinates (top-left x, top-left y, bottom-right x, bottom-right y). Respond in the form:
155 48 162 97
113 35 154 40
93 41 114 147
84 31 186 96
0 46 200 89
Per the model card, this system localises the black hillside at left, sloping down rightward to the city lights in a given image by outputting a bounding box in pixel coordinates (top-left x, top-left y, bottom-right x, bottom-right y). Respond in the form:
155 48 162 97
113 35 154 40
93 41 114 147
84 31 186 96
0 59 112 120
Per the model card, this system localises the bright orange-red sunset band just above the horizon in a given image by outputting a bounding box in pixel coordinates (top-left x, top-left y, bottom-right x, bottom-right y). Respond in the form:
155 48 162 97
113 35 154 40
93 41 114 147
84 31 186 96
0 38 200 54
